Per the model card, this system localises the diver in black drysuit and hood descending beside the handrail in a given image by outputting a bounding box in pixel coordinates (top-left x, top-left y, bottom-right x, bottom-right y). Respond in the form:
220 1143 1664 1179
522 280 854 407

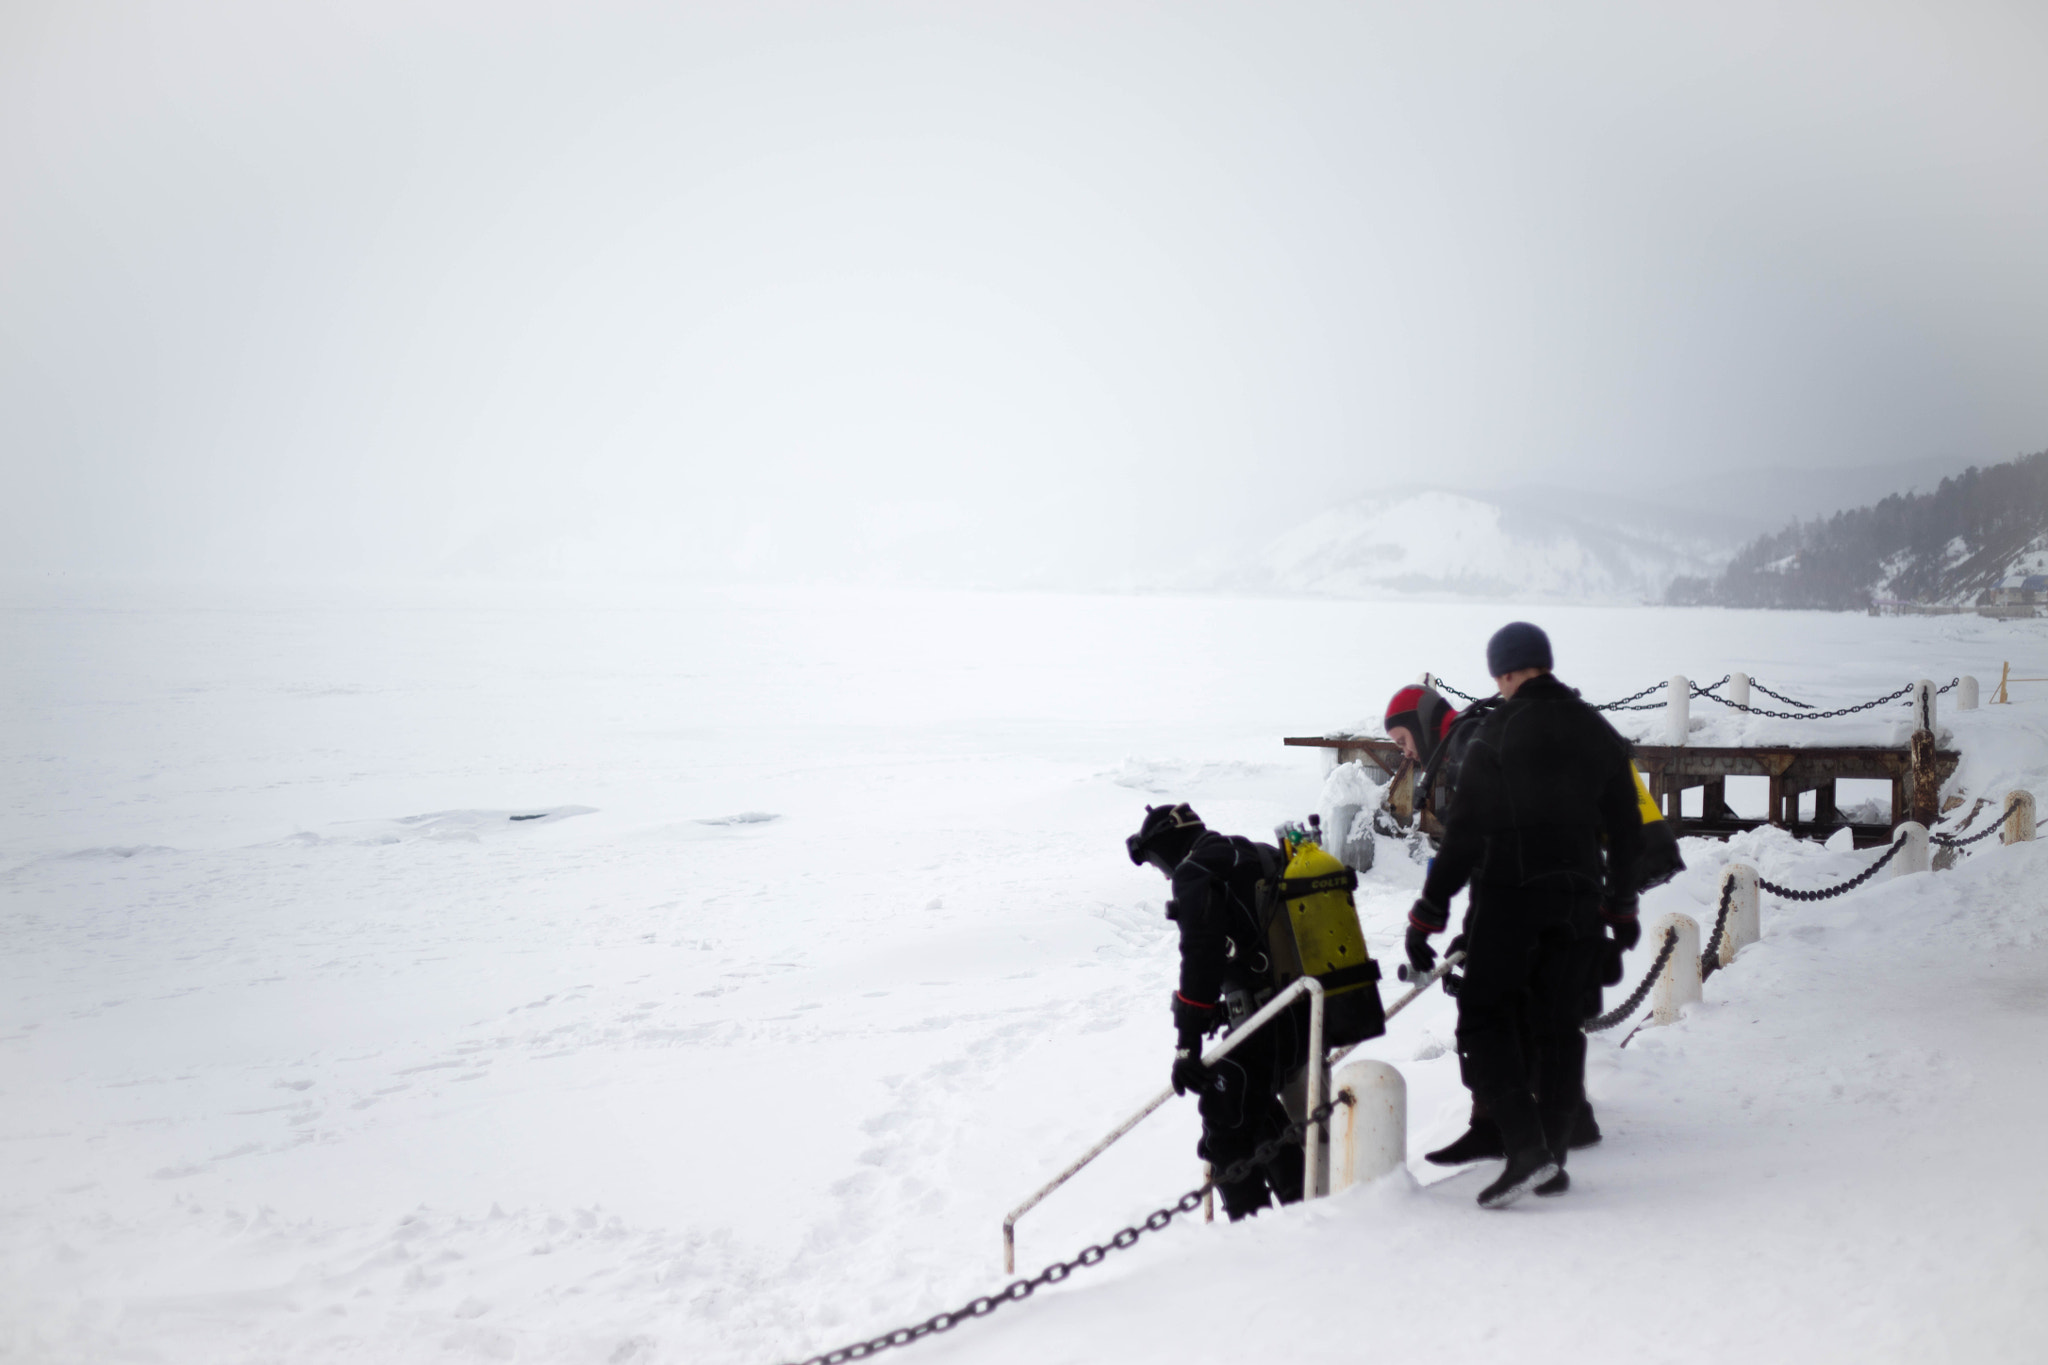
1124 806 1307 1222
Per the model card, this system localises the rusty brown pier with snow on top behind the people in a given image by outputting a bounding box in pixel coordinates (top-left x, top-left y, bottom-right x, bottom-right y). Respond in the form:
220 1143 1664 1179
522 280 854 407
1282 731 1960 847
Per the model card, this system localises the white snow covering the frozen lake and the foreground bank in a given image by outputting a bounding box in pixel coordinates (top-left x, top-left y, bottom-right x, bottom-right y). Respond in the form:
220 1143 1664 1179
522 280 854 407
0 589 2048 1365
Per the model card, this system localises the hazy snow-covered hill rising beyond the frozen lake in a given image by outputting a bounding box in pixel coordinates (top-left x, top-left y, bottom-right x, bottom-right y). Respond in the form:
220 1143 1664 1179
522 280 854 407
1243 489 1735 602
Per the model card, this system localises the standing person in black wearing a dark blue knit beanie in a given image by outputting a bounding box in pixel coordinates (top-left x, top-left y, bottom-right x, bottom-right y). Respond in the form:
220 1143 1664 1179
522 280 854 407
1407 622 1642 1207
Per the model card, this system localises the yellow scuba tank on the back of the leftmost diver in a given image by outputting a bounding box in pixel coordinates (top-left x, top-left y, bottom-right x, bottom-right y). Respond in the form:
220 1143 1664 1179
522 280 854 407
1264 825 1386 1046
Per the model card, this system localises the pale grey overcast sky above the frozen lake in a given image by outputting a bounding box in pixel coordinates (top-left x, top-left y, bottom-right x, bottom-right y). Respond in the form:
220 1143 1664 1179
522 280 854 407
0 0 2048 581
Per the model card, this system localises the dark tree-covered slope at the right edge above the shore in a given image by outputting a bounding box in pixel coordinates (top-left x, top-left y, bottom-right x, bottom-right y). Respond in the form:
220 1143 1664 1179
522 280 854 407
1665 450 2048 612
